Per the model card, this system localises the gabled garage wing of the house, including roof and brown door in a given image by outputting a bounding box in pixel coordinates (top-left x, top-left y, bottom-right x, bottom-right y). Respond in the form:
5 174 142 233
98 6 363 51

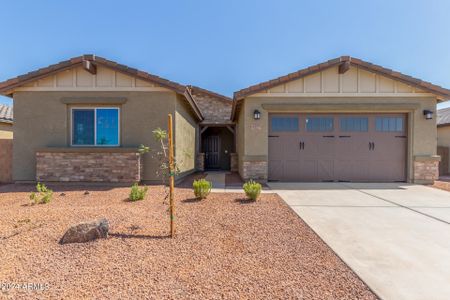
232 56 450 183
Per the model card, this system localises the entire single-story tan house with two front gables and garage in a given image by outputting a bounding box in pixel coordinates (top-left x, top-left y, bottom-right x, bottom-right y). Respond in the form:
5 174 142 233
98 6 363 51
0 55 450 183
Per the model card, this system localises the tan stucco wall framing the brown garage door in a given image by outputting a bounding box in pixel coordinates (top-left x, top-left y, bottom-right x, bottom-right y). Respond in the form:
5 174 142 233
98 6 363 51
237 95 437 181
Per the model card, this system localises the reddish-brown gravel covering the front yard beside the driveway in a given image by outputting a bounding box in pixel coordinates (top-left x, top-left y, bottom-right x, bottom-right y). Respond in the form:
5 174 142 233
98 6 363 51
0 185 376 299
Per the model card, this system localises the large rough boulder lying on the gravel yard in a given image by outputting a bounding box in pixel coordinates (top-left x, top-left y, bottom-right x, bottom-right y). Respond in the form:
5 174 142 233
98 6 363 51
59 219 109 244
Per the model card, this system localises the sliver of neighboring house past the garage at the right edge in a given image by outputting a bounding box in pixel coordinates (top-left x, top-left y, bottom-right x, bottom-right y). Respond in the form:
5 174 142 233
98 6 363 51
437 108 450 175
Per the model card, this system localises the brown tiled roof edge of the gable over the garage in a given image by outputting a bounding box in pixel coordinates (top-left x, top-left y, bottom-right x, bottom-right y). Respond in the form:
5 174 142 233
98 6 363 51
234 56 450 101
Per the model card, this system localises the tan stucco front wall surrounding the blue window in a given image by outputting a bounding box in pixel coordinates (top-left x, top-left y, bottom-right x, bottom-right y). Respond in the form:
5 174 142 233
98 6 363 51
13 92 176 181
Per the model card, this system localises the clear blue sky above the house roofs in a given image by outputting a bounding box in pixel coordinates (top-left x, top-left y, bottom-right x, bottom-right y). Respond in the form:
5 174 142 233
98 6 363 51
0 0 450 109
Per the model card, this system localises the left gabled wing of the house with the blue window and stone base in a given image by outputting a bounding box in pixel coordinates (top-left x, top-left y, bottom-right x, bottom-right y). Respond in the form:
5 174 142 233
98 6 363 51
0 55 231 182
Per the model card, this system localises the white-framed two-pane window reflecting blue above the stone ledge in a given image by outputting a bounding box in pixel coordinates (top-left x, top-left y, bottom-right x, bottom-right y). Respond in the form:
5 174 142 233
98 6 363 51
72 107 119 146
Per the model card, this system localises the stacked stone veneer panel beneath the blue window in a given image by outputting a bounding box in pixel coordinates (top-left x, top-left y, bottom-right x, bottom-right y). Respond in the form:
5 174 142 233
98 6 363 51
36 149 142 183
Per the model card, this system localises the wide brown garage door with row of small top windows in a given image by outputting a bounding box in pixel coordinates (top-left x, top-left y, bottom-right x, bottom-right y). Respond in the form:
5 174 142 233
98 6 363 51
269 114 407 182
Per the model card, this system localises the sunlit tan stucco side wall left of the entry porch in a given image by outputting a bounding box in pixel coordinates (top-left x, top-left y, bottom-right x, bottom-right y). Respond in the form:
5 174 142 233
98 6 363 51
175 97 197 176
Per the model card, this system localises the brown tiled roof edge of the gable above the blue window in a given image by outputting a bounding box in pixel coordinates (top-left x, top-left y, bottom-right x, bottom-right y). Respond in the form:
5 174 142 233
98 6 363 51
0 54 203 120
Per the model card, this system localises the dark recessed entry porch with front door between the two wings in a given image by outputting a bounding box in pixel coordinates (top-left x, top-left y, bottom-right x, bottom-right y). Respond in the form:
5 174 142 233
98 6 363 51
197 122 237 172
